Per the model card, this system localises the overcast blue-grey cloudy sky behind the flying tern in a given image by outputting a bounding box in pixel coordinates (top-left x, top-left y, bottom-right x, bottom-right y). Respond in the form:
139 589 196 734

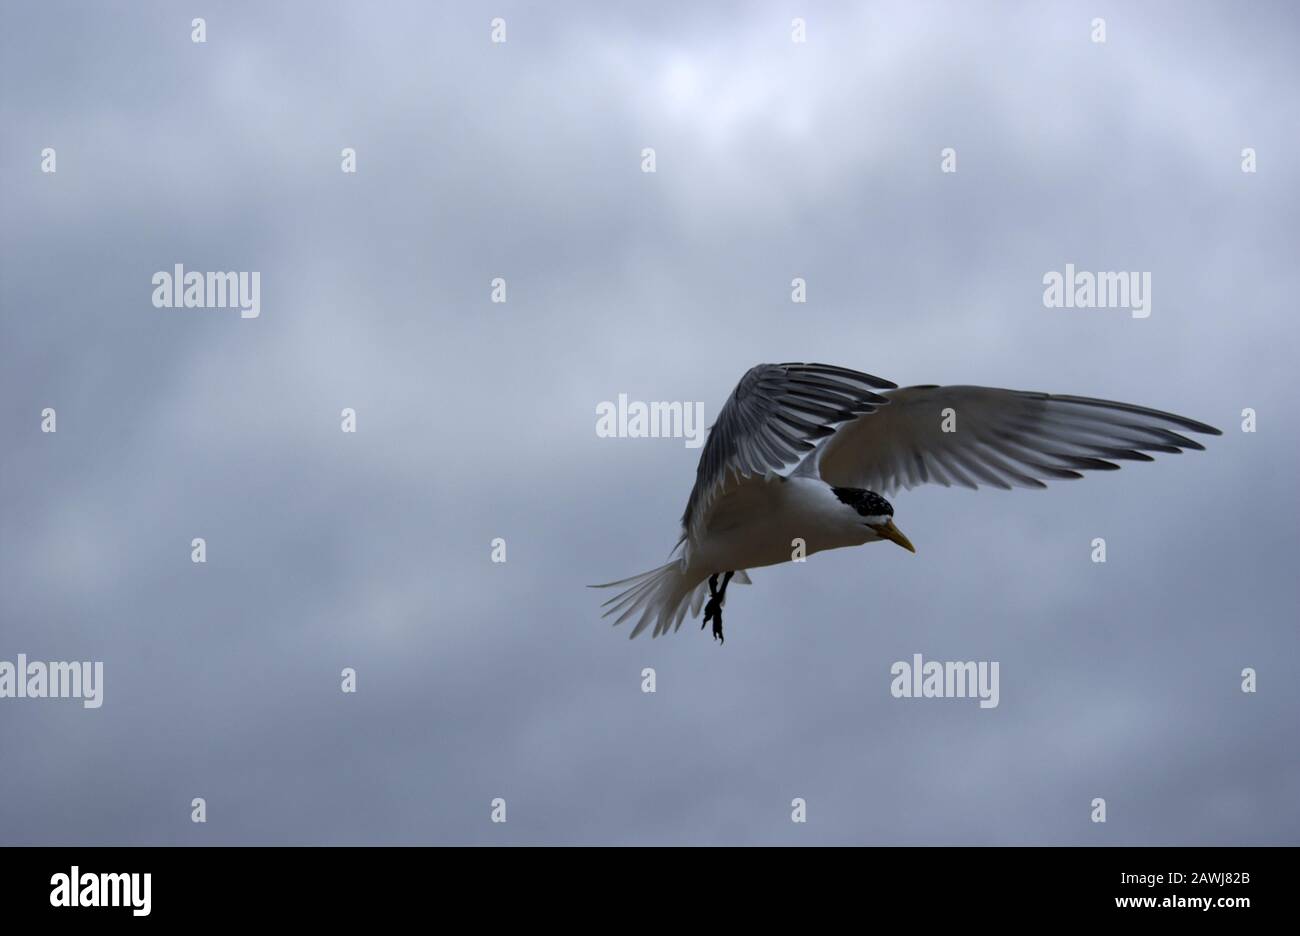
0 0 1300 844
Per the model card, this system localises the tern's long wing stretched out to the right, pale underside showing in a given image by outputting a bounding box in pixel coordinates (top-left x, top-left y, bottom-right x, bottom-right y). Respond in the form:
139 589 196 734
816 386 1222 494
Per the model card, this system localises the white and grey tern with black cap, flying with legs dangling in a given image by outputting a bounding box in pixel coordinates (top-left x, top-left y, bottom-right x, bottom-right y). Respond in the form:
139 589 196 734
593 364 1222 641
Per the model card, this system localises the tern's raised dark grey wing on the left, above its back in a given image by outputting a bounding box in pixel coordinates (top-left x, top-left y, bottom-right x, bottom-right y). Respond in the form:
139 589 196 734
681 364 897 541
